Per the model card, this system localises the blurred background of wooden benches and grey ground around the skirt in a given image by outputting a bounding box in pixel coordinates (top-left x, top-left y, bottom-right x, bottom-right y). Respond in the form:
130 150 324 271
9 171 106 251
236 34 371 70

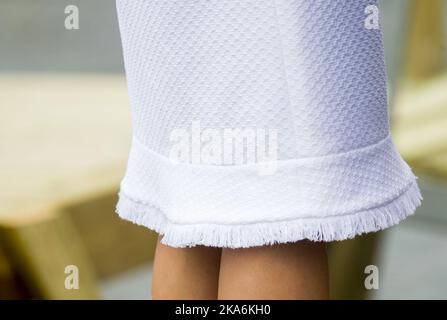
0 0 447 299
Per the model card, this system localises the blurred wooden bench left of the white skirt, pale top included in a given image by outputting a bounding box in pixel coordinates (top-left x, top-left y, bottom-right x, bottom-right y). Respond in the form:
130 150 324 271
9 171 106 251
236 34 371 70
0 73 155 299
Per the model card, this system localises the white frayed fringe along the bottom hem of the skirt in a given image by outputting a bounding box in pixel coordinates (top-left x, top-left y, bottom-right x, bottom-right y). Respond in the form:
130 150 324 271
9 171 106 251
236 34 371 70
116 182 422 248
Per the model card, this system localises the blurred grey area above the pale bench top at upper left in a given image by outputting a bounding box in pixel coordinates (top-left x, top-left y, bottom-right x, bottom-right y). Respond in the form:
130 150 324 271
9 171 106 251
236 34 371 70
0 0 123 72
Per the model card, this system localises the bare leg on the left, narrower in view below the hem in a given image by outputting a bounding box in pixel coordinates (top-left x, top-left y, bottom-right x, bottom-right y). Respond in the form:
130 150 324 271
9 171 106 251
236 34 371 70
152 235 221 300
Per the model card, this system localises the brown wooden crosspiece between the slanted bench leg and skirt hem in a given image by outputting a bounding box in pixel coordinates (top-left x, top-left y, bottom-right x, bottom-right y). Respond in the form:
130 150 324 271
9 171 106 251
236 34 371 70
65 189 157 277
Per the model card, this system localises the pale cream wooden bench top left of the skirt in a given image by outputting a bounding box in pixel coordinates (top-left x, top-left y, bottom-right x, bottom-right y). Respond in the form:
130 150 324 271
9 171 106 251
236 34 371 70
0 73 131 219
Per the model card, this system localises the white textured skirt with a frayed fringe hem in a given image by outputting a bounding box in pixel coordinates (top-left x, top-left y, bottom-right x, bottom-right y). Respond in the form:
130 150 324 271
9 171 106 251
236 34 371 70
117 0 421 247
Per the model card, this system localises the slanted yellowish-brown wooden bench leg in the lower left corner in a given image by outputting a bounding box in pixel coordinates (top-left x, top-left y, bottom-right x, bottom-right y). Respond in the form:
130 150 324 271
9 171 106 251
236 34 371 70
0 209 98 299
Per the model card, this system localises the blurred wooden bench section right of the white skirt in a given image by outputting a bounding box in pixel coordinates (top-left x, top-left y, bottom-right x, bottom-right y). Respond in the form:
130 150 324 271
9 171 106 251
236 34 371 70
392 0 447 178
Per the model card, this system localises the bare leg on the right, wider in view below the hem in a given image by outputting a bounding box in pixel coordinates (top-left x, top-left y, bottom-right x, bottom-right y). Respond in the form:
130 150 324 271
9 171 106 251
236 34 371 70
218 241 329 299
